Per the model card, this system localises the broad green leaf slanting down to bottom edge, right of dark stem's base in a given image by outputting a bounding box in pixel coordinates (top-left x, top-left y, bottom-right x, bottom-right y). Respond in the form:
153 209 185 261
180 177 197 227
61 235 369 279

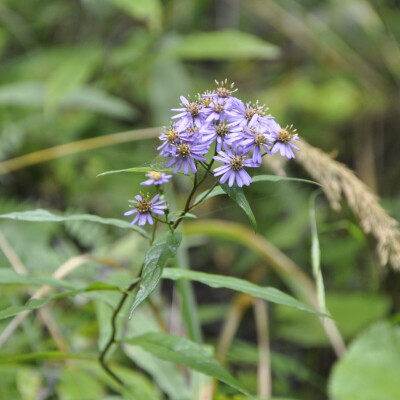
124 332 253 398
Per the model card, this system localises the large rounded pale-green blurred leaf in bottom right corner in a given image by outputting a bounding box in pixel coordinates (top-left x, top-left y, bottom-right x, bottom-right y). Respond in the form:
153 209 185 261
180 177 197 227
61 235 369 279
329 323 400 400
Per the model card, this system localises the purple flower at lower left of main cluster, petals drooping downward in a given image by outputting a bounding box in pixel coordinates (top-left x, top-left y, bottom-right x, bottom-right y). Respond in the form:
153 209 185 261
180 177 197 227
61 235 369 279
167 142 210 175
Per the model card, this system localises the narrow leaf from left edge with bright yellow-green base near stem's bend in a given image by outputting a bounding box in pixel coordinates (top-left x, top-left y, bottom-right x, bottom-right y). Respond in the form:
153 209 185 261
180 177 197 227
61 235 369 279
0 282 121 319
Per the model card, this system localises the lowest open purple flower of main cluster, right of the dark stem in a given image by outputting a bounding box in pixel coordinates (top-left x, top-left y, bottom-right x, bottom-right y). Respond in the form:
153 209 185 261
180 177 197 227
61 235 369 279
213 147 259 187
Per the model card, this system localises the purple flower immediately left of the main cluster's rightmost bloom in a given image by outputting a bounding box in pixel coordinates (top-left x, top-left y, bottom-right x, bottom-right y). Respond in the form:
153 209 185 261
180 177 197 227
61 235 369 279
240 117 274 164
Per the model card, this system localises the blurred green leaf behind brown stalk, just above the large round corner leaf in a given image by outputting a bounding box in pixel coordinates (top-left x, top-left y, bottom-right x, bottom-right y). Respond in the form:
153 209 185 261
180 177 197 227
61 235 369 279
275 292 390 347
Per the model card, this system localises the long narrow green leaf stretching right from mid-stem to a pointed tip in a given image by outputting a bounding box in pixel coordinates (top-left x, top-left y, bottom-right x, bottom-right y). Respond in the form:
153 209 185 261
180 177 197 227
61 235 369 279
163 268 324 315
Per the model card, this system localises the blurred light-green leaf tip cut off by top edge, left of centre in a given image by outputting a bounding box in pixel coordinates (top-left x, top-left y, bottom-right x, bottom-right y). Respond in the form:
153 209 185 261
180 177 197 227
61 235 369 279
109 0 162 30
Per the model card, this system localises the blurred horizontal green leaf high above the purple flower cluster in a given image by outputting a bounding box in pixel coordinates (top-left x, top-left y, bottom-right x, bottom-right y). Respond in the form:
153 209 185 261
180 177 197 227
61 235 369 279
164 29 279 60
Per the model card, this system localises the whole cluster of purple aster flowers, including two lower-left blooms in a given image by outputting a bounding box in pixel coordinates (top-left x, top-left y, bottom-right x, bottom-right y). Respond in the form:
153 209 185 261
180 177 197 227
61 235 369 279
125 80 299 226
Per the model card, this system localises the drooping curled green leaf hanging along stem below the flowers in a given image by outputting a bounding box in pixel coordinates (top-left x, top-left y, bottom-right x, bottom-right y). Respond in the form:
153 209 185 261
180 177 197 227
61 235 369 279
130 232 182 316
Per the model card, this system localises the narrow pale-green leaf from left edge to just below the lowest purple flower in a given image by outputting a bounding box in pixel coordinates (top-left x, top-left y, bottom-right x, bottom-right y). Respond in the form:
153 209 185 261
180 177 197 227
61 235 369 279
0 209 150 238
